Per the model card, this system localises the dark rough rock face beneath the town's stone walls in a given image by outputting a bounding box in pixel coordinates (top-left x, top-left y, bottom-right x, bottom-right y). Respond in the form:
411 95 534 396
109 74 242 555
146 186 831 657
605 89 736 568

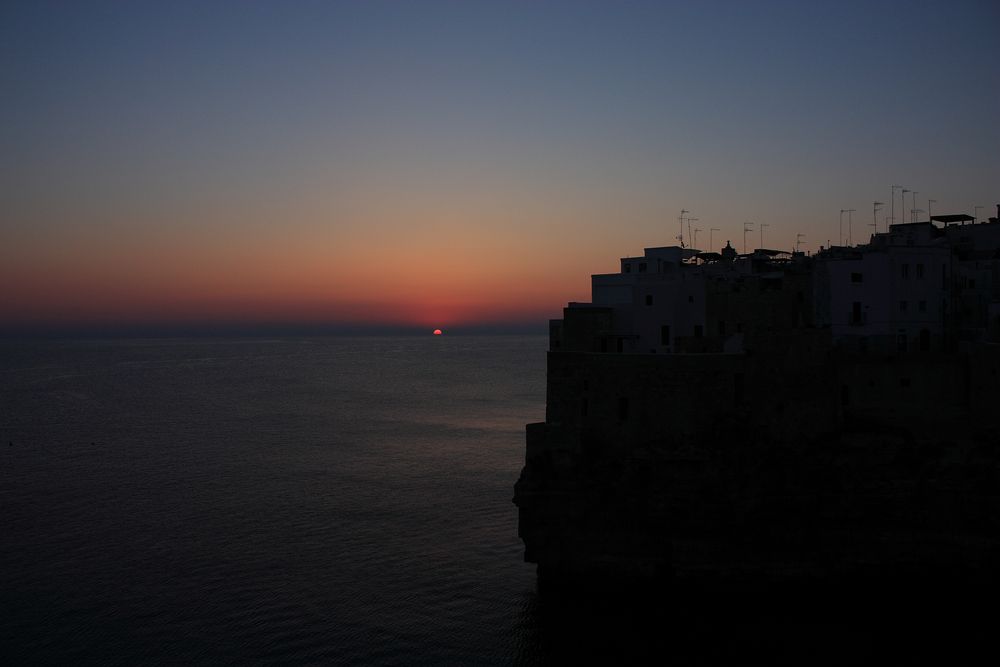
514 366 1000 585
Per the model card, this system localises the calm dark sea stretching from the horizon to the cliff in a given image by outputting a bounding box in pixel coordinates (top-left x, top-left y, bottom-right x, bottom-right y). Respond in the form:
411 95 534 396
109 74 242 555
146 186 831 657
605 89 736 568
0 336 546 664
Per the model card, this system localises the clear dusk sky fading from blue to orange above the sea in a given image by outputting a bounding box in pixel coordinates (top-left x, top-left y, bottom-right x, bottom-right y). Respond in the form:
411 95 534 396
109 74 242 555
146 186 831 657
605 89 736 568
0 0 1000 332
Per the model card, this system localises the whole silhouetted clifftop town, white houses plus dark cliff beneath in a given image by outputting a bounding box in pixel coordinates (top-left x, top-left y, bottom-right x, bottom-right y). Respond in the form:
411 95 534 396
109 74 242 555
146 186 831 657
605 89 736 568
514 207 1000 581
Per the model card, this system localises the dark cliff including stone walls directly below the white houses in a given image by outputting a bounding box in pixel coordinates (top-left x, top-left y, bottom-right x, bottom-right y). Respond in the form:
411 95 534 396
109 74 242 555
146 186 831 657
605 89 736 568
514 348 1000 586
